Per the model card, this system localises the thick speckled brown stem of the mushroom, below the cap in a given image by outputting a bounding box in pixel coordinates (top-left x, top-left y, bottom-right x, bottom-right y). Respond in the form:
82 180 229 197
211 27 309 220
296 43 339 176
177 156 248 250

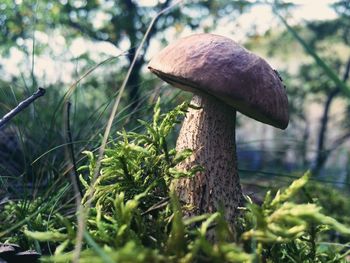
173 94 243 226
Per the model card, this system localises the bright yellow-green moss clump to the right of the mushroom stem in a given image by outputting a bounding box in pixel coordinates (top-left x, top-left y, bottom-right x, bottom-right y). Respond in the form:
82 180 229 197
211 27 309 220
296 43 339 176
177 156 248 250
242 172 350 263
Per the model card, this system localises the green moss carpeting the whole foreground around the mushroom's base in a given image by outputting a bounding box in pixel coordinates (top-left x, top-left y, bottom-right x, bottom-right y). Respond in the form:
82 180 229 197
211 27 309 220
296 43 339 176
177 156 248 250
0 101 350 262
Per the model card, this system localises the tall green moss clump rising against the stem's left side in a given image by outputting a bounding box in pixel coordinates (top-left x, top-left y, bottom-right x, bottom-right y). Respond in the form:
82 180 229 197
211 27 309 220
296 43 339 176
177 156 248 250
80 101 200 205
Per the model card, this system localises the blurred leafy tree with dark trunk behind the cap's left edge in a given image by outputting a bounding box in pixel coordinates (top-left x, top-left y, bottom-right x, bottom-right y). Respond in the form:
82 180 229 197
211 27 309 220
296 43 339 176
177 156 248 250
0 0 251 108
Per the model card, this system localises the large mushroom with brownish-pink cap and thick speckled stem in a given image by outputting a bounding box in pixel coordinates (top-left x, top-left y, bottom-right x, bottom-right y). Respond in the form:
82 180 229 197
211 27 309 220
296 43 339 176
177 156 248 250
148 34 289 226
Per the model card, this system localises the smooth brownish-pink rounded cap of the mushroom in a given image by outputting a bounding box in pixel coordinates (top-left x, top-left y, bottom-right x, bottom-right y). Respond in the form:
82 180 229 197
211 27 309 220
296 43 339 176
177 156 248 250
148 34 289 129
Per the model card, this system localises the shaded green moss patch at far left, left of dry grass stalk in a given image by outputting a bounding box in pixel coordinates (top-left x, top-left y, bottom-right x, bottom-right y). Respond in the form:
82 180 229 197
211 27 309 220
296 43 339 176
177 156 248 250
0 185 74 248
